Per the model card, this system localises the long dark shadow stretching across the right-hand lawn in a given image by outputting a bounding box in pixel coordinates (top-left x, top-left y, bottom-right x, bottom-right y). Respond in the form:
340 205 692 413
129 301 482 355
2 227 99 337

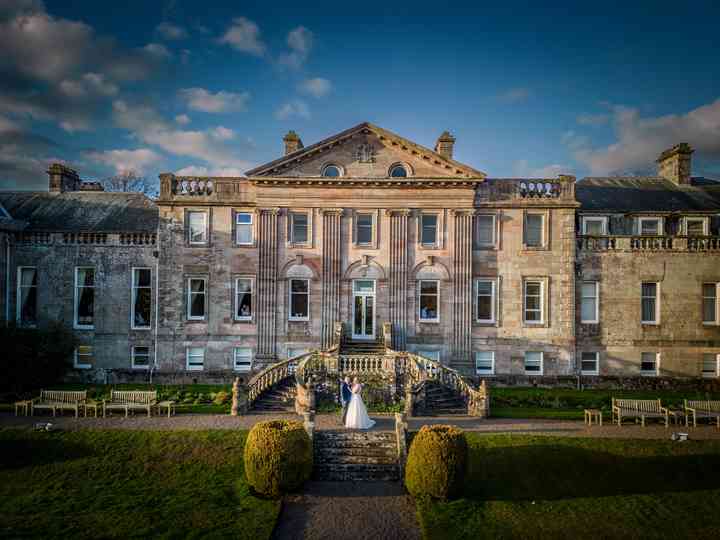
465 445 720 501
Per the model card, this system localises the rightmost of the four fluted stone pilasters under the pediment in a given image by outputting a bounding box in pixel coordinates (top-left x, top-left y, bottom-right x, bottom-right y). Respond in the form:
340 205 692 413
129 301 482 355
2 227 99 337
453 210 475 368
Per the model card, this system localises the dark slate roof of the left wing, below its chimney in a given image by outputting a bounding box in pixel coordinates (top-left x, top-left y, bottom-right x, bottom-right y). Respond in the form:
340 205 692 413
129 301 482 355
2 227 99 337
0 191 158 233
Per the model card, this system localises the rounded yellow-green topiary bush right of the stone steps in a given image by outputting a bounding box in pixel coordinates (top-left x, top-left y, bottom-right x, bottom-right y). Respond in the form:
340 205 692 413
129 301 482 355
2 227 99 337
405 425 468 499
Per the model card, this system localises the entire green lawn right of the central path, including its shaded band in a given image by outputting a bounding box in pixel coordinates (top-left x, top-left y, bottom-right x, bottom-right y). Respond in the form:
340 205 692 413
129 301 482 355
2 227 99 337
418 434 720 540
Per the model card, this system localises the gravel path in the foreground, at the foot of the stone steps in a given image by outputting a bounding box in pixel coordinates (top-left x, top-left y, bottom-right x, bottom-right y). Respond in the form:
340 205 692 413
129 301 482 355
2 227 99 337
273 482 421 540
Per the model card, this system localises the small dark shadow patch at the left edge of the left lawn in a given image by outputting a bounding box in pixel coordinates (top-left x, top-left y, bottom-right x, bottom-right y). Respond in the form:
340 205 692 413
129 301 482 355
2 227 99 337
0 434 93 470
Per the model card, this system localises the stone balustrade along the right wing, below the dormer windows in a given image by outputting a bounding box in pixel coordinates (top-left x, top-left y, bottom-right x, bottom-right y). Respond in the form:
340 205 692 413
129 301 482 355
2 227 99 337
577 236 720 253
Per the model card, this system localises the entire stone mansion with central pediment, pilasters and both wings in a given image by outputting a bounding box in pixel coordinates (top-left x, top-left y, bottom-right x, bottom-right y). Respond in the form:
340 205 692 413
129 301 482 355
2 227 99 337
0 123 720 382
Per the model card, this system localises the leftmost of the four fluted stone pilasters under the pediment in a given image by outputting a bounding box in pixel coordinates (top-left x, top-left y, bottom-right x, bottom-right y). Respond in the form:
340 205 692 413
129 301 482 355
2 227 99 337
256 208 280 362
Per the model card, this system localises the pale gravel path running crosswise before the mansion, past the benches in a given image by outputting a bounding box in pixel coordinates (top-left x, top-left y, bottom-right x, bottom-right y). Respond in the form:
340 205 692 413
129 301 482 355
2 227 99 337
0 413 720 439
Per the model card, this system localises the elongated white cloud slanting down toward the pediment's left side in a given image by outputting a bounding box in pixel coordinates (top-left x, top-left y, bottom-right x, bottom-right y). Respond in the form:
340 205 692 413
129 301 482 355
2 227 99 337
113 100 255 168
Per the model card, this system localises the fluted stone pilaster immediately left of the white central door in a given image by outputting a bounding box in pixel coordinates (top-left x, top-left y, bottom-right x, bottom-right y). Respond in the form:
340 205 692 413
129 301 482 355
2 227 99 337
321 208 343 350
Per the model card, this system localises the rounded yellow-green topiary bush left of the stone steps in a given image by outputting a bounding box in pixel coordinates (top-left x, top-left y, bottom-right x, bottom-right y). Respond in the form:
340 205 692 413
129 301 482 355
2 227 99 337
245 420 313 497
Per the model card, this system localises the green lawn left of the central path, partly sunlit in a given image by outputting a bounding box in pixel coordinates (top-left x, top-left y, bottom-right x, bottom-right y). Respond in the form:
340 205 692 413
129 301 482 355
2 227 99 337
0 429 280 540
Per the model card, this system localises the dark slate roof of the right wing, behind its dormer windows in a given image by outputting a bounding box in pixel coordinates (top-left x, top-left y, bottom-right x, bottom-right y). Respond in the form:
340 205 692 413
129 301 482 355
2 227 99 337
575 176 720 212
